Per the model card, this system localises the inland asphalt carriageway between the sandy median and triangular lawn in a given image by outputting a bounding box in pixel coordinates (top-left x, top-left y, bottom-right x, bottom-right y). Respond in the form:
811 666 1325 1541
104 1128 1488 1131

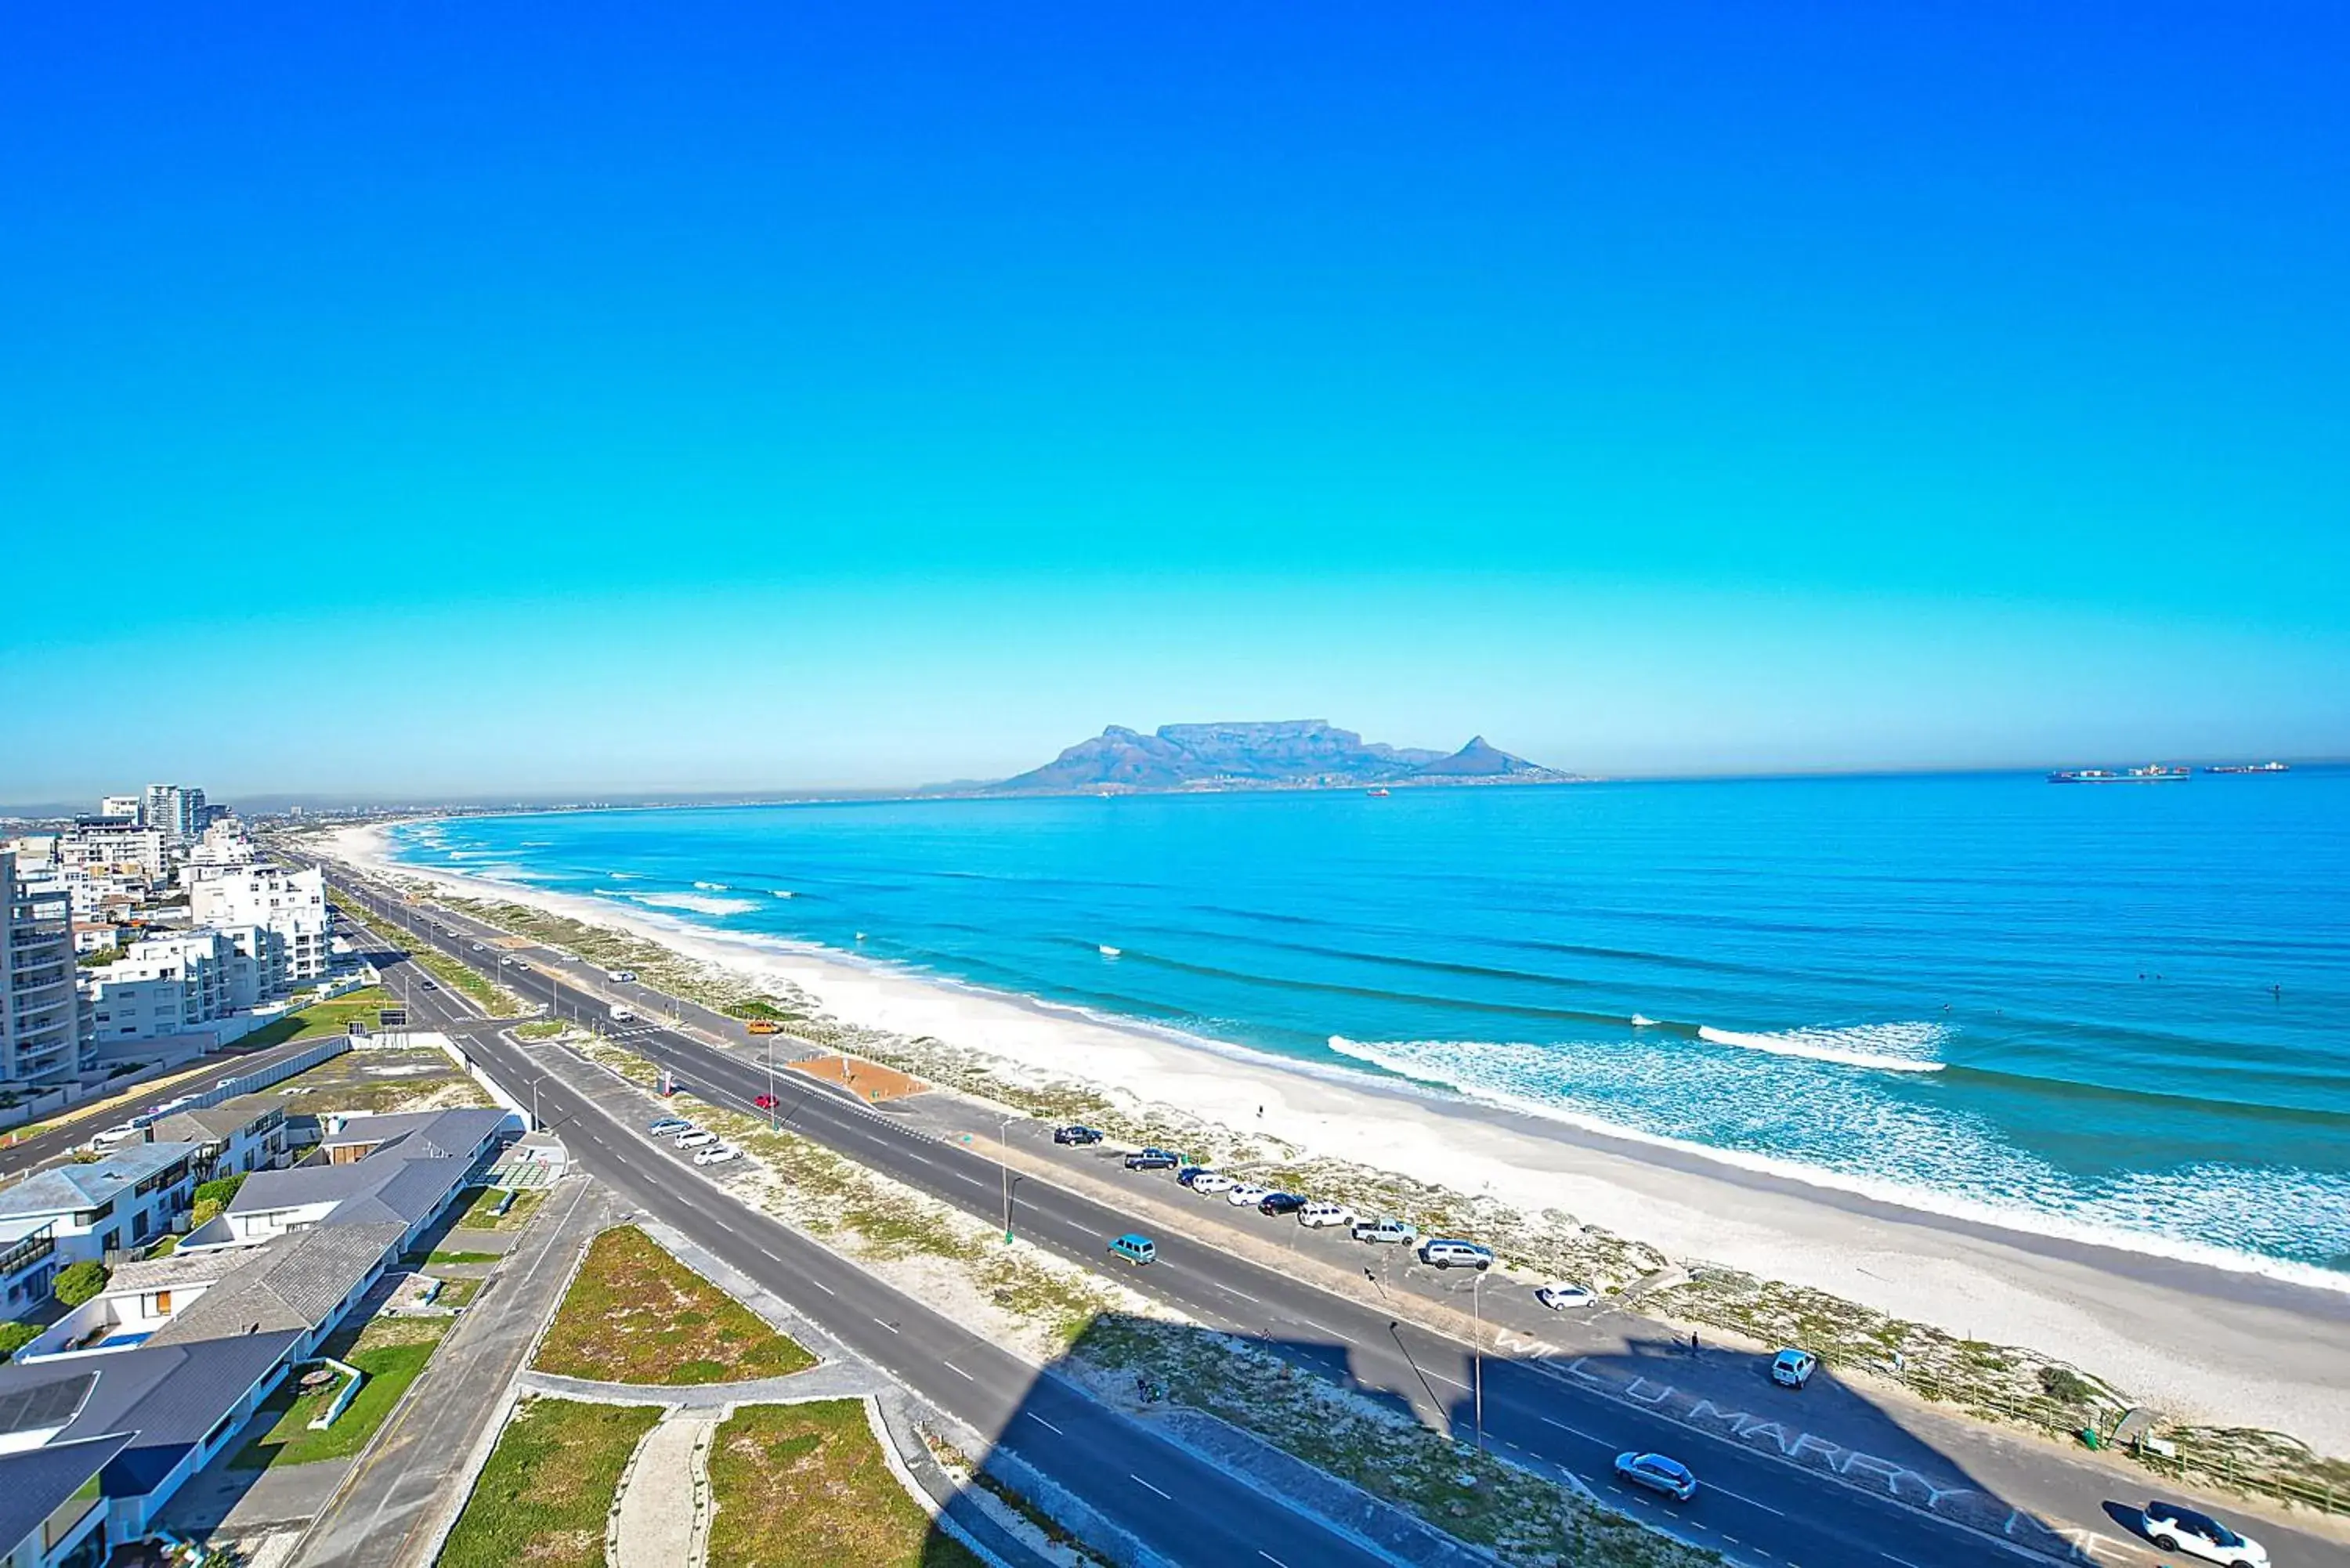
343 912 1384 1568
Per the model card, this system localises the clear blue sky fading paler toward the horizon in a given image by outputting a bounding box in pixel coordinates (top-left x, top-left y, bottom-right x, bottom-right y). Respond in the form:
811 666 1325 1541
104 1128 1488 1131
0 5 2350 802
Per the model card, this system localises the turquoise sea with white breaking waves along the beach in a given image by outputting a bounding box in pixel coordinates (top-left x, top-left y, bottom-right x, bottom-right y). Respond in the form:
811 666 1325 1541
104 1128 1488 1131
395 768 2350 1274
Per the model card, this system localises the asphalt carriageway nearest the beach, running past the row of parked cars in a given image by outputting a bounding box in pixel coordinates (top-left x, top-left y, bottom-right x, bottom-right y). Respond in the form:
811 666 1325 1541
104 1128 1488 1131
331 894 2350 1568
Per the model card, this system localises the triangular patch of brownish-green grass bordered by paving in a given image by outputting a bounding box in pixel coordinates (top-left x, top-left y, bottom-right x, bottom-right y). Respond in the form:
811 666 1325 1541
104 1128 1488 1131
536 1225 815 1385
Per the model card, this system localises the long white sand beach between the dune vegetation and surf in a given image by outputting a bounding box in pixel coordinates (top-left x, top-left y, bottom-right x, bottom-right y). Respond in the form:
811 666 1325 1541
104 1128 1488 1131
327 826 2350 1453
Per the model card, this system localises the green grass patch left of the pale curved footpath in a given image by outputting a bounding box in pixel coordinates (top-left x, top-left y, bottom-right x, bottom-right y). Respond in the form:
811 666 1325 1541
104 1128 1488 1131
439 1399 663 1568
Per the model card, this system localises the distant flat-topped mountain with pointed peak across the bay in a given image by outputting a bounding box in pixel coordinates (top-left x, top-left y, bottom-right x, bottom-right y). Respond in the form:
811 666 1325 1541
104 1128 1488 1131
987 719 1574 795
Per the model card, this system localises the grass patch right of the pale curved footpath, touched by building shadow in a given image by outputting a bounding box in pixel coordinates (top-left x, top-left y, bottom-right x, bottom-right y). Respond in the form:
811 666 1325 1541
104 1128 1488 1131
710 1399 980 1568
